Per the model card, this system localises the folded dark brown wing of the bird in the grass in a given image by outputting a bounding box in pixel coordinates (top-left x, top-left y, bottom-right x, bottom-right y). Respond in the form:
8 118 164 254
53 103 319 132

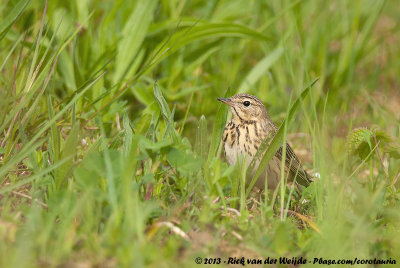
275 143 312 187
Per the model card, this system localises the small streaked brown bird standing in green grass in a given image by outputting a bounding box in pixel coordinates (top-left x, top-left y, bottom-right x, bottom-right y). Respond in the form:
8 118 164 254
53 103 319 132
218 94 312 190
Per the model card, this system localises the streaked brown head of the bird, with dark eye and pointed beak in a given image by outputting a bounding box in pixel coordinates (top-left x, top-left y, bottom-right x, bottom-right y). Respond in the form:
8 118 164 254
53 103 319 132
217 93 269 122
